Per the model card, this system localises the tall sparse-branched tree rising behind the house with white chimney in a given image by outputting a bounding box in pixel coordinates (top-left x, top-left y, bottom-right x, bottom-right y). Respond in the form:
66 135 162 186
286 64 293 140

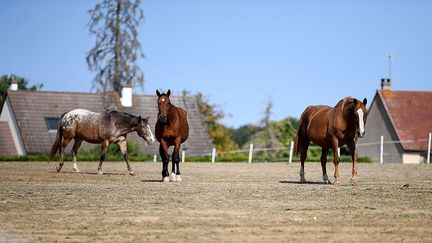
86 0 144 94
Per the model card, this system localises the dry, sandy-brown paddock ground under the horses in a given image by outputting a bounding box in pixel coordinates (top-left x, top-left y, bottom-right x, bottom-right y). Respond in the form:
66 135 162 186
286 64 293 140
0 162 432 242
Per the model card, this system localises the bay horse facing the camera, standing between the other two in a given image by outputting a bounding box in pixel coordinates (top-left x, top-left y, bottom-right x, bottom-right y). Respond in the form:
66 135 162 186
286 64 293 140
155 90 189 182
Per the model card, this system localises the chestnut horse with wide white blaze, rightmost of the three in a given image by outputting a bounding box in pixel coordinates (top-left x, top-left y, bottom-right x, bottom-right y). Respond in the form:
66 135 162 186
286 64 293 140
294 97 367 183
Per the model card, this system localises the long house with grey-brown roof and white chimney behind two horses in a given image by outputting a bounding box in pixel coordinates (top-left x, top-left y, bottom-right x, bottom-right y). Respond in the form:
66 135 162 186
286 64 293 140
0 84 213 159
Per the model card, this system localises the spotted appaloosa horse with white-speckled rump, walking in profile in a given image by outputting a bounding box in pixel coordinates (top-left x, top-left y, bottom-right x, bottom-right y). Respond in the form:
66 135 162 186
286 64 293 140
50 109 154 175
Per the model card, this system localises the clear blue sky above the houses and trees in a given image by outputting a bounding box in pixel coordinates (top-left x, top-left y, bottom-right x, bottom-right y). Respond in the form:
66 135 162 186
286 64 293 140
0 0 432 127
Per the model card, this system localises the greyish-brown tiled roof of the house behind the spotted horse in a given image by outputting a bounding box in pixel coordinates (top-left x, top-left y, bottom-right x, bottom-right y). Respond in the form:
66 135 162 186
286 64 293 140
8 90 212 154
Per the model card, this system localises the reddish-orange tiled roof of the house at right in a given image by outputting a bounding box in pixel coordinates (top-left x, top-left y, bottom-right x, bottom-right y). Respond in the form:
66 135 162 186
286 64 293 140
378 90 432 151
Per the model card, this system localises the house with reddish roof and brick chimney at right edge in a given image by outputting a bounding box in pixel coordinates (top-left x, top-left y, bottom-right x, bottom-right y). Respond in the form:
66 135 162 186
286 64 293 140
357 79 432 163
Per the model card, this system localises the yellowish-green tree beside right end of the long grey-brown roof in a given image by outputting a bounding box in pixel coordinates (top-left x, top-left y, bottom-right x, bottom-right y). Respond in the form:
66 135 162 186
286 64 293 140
196 92 238 152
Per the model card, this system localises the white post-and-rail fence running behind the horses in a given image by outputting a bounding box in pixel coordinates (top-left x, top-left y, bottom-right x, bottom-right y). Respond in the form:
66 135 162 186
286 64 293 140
153 133 432 164
